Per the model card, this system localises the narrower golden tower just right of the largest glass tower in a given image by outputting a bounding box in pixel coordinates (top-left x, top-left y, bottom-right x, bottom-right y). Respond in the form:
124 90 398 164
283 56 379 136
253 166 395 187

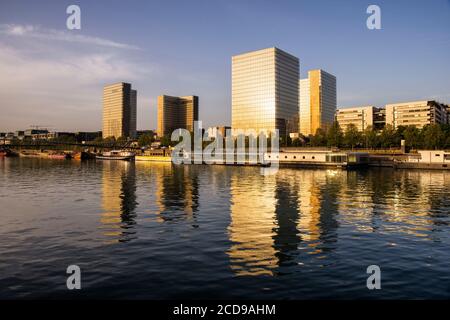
299 69 336 135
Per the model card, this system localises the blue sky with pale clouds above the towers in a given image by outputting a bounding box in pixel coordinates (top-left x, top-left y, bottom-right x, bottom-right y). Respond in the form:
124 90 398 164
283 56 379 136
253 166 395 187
0 0 450 132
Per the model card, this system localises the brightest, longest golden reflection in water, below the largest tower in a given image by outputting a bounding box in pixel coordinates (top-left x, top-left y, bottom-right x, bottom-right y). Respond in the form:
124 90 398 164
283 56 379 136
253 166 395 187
227 168 278 276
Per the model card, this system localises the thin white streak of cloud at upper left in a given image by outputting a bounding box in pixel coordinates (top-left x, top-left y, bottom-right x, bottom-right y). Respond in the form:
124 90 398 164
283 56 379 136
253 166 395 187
0 24 139 50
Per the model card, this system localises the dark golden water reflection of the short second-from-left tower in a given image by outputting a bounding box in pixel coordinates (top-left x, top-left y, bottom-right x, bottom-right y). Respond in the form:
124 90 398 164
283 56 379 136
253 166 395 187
156 165 199 221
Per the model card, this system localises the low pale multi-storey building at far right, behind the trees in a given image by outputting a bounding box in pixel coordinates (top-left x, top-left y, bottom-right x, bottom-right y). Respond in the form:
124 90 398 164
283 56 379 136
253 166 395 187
386 100 448 128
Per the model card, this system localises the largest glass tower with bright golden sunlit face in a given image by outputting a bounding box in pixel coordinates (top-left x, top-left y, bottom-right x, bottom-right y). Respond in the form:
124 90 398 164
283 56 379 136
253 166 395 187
231 48 299 136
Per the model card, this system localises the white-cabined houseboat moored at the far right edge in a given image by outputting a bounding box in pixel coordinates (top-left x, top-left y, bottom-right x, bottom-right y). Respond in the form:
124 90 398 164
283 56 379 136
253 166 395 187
394 150 450 170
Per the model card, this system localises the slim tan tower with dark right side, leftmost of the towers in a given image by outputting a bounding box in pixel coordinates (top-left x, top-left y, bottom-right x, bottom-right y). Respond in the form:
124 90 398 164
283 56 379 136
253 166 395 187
102 82 137 139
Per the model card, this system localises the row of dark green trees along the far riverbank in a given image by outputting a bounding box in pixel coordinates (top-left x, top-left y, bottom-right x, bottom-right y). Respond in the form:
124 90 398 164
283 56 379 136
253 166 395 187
0 122 450 154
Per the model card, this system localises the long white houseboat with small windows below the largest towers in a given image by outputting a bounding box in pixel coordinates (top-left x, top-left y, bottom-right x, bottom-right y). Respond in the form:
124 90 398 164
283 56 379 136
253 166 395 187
264 149 369 168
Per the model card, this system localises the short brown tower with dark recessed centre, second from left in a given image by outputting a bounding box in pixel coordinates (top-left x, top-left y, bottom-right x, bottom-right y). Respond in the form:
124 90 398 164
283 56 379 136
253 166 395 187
157 95 198 137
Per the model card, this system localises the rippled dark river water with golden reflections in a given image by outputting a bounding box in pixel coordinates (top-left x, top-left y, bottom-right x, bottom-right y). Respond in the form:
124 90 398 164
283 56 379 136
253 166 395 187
0 158 450 299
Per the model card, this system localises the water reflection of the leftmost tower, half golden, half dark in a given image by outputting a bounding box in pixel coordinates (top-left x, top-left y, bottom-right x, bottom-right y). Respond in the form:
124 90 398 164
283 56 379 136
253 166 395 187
100 161 137 242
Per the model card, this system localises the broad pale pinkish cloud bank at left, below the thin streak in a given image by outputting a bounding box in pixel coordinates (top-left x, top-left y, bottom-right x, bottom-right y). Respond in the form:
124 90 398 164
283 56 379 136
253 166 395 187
0 41 153 131
